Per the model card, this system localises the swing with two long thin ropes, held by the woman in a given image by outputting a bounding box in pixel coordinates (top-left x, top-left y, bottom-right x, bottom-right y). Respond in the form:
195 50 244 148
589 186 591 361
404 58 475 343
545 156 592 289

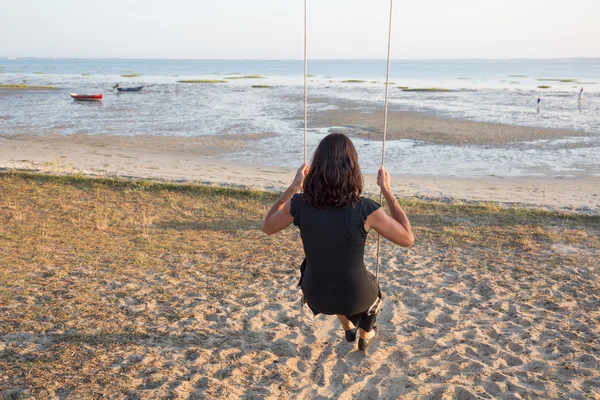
301 0 394 315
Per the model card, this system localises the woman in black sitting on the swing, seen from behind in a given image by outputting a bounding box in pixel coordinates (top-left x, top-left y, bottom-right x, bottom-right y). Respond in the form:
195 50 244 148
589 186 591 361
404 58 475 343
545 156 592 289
262 133 414 350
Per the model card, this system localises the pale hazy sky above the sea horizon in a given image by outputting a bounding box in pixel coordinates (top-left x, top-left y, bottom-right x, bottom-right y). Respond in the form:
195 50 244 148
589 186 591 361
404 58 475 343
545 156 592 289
0 0 600 59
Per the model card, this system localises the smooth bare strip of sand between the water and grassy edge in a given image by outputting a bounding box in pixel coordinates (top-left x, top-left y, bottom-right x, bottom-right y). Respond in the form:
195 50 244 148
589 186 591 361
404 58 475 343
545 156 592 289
0 134 600 214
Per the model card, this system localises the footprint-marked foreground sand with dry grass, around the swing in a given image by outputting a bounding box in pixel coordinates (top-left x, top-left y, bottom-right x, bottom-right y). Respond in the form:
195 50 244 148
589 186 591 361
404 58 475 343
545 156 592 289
0 173 600 400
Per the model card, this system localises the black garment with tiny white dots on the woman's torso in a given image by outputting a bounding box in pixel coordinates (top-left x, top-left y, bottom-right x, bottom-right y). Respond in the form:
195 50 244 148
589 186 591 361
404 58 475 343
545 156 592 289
290 194 381 315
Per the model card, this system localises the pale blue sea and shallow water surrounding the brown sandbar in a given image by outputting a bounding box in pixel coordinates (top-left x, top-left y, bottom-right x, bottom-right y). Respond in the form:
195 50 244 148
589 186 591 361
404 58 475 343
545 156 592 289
0 59 600 177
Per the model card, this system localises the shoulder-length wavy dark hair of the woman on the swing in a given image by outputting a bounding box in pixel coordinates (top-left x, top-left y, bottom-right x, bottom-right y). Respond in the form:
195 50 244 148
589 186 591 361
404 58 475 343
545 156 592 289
302 133 363 208
